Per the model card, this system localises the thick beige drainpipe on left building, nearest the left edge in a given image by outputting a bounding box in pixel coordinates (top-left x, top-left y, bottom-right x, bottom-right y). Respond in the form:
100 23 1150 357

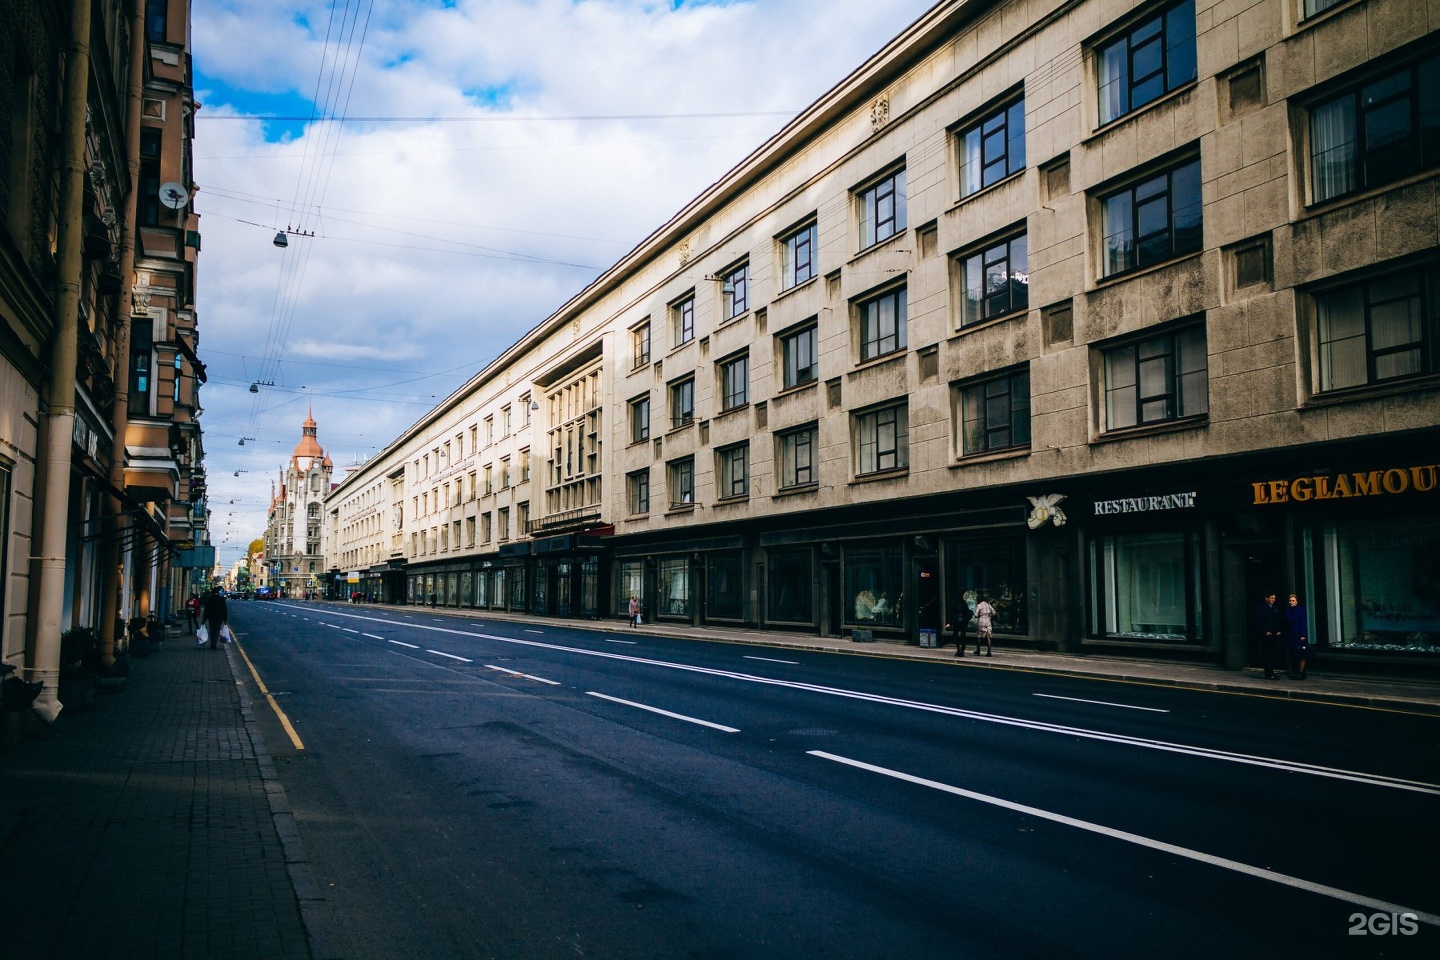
29 0 91 723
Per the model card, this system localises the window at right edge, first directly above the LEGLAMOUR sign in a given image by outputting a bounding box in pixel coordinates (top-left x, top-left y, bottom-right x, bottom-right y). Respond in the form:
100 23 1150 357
1315 265 1440 390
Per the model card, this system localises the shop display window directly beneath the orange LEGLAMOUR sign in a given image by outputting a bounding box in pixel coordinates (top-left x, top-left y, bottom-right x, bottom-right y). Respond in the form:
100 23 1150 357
1305 518 1440 655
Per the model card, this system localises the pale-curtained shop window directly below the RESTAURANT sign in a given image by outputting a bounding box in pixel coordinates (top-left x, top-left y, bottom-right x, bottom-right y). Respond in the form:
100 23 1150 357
1090 531 1201 642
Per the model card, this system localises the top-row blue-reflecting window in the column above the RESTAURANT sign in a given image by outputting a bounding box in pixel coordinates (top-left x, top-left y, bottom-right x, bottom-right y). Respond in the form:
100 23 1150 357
1096 0 1195 124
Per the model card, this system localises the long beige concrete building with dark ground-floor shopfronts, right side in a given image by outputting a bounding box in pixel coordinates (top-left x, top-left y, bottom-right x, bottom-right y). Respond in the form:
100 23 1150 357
327 0 1440 668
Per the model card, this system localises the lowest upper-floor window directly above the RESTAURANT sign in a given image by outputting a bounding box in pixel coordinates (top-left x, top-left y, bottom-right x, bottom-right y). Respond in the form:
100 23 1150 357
1104 325 1210 430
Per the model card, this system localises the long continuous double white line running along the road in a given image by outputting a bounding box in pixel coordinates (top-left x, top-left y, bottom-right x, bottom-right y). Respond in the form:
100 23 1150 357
289 613 1440 796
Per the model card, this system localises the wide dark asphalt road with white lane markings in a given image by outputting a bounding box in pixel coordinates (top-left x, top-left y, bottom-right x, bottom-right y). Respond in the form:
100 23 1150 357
230 602 1440 960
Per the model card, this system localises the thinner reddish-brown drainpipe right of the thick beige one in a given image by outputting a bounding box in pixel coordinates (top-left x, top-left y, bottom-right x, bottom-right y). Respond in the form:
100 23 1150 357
99 0 145 666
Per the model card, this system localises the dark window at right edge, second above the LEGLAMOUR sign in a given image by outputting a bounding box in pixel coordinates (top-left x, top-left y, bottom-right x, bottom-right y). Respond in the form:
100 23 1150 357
1310 55 1440 203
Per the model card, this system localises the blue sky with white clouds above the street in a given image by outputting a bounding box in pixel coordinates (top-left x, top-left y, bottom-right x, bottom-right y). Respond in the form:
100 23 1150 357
192 0 933 569
